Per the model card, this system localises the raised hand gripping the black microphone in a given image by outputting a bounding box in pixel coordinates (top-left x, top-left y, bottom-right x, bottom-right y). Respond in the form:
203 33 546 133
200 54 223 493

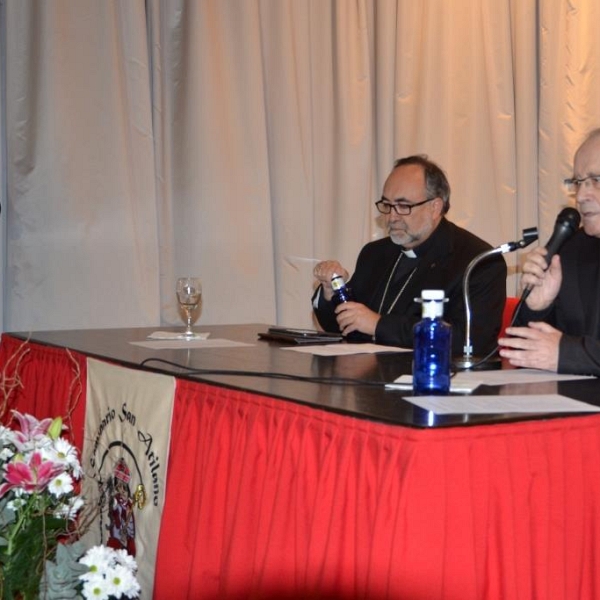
521 247 562 310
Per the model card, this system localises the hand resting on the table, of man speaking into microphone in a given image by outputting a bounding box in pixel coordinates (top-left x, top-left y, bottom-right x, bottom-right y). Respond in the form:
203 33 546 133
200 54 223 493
498 322 562 371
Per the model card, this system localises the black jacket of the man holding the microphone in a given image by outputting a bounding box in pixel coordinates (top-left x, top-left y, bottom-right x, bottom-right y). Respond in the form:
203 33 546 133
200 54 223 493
516 229 600 375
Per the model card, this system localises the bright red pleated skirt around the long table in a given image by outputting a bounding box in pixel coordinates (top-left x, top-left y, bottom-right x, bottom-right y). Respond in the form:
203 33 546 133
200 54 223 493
0 335 600 600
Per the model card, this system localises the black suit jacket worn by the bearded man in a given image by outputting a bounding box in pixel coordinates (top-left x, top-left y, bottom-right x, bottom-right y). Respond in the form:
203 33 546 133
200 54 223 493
313 219 506 356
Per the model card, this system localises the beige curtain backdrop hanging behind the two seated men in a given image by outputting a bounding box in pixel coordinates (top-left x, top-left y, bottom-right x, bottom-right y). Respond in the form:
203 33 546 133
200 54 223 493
0 0 600 331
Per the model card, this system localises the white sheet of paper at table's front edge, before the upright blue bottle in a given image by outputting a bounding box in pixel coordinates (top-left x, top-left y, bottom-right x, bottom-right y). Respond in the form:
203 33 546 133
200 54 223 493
404 394 600 415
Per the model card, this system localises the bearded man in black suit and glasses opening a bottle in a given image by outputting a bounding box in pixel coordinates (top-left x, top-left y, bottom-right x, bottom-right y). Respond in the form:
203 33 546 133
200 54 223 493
313 155 506 355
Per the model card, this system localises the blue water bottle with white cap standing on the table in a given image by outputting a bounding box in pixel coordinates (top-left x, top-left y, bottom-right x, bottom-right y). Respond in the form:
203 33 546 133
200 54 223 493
413 290 452 396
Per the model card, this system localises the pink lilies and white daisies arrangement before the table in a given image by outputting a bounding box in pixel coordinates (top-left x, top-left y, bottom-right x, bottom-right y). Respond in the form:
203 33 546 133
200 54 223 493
0 411 140 600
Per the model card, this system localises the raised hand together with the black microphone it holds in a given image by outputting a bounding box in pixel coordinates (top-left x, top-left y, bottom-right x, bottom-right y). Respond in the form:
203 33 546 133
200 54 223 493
521 208 581 310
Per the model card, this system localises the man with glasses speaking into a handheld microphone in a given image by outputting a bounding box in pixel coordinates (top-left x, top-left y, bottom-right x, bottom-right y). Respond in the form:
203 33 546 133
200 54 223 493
499 129 600 376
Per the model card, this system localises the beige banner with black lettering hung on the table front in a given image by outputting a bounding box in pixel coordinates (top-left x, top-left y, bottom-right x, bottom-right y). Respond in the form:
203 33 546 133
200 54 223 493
82 358 175 598
